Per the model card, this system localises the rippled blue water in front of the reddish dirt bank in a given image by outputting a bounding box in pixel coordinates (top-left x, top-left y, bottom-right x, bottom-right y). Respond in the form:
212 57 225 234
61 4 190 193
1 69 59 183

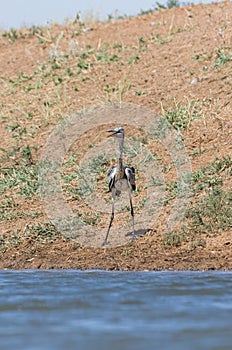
0 270 232 350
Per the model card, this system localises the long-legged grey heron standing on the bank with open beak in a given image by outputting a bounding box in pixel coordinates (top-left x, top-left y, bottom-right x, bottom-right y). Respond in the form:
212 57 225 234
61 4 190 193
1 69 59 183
103 126 136 246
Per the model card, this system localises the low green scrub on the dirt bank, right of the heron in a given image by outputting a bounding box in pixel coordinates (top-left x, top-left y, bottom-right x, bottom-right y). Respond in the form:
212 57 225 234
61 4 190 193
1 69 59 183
164 157 232 247
